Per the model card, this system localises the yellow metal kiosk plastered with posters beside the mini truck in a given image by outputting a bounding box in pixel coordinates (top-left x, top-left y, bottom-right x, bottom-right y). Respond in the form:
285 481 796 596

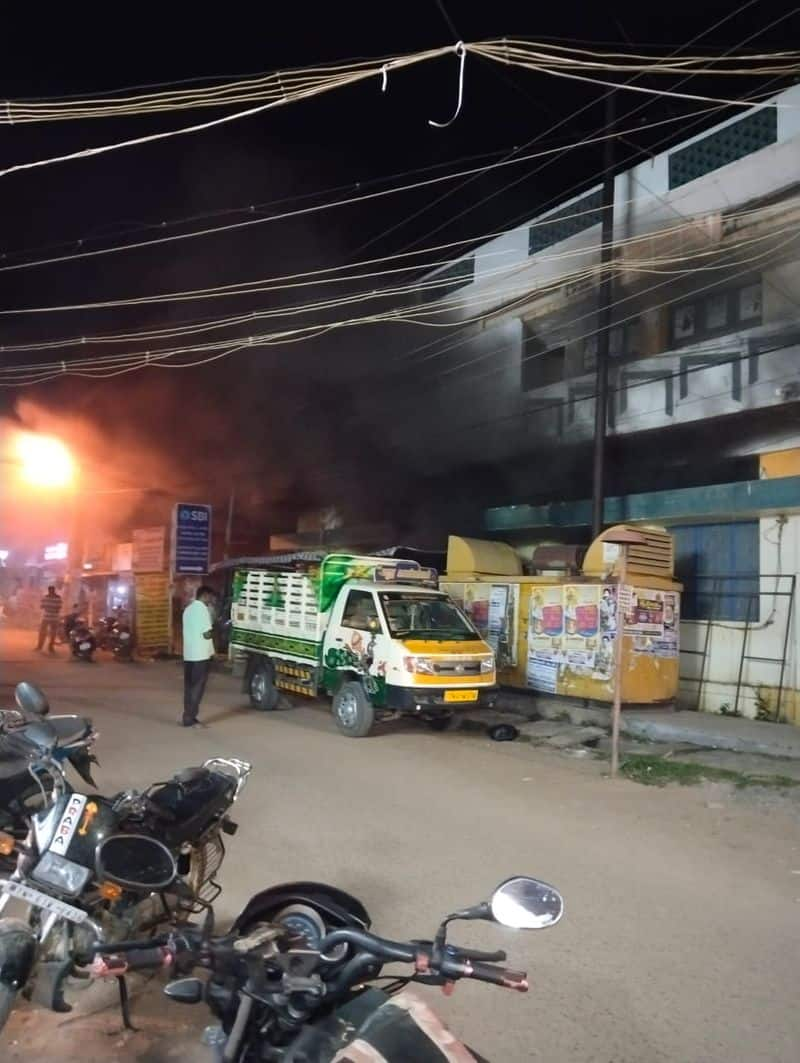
440 525 682 705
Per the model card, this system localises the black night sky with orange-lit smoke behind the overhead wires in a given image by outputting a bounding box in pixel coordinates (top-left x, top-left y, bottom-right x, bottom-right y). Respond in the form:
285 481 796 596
0 8 797 552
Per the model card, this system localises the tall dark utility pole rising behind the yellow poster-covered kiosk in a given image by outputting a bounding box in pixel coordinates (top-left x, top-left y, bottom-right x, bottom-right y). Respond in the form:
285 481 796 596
592 89 616 540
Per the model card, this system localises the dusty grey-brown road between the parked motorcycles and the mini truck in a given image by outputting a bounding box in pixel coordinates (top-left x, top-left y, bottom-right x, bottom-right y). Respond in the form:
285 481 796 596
0 620 800 1063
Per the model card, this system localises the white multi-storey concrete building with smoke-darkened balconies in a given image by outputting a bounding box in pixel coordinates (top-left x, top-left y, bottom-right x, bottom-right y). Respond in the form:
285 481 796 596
390 86 800 720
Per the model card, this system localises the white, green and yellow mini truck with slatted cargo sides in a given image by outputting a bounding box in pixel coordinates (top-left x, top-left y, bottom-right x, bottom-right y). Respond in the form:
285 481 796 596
231 554 495 738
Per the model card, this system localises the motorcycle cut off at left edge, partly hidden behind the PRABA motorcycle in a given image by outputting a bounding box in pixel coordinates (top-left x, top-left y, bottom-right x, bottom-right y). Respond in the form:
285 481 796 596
0 684 98 873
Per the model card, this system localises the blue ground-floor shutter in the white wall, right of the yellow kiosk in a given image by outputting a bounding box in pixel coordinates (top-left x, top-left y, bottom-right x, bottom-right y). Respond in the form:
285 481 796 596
670 521 760 621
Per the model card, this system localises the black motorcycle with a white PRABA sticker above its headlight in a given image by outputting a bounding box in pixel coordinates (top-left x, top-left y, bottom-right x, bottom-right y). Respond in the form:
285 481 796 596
0 680 251 1029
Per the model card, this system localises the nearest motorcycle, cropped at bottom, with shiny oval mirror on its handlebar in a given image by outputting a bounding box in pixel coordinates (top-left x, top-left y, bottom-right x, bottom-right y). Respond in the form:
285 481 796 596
82 867 564 1063
